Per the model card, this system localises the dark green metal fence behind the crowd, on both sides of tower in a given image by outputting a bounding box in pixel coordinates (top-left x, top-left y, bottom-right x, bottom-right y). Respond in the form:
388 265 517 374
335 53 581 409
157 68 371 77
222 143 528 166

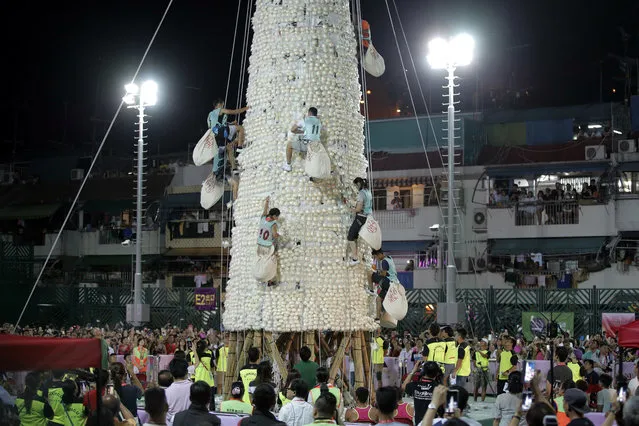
0 287 639 336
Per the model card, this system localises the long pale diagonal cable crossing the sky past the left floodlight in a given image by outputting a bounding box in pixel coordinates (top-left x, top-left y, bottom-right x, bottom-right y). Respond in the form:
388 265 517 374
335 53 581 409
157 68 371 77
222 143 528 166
12 0 173 333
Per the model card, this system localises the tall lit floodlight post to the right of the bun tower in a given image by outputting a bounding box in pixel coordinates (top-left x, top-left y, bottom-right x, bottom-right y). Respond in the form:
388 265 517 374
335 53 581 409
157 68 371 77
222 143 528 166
427 34 475 323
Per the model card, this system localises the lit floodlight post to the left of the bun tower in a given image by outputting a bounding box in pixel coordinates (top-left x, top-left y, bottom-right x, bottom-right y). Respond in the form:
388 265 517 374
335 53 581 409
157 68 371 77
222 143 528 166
122 81 158 326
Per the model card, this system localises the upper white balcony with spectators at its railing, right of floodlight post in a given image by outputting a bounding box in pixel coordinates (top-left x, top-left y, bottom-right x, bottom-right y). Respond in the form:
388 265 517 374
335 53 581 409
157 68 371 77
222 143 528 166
488 200 617 239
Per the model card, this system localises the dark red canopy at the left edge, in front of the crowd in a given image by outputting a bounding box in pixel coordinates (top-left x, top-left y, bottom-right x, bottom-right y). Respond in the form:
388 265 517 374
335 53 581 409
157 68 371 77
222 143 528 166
0 334 102 371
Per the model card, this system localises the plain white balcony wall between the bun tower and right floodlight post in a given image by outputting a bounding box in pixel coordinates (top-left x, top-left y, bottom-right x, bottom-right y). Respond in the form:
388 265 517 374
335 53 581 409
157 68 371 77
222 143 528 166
373 206 441 241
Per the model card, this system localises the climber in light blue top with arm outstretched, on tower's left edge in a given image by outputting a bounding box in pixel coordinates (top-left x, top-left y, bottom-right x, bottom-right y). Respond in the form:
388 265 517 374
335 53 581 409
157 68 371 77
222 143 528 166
206 99 248 180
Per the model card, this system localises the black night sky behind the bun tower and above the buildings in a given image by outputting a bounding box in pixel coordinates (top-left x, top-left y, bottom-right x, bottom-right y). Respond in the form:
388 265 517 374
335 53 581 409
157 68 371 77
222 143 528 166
0 0 639 163
